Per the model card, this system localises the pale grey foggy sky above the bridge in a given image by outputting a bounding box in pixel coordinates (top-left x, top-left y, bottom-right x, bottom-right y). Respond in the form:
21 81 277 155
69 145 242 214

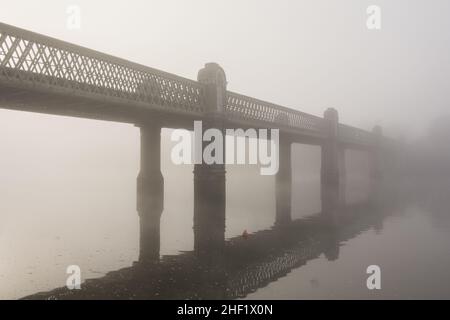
0 0 450 138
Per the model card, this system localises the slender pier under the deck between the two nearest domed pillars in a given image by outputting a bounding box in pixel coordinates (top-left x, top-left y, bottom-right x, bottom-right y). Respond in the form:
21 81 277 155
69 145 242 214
275 135 292 226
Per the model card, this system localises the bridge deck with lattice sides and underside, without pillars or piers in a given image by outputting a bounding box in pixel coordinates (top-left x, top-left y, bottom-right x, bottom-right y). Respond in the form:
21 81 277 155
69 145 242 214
0 23 373 146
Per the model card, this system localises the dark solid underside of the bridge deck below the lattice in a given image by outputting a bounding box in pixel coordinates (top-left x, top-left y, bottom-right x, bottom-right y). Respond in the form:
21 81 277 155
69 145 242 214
0 82 330 149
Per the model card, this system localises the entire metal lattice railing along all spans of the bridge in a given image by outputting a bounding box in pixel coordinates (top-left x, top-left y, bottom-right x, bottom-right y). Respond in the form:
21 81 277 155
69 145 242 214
0 23 380 145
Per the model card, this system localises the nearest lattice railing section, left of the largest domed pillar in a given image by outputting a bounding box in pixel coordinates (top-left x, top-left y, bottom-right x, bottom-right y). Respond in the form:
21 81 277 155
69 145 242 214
0 23 204 111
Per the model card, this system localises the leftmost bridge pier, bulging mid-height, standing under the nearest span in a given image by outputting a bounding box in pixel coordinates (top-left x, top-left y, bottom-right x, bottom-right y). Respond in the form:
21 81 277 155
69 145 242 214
137 123 164 263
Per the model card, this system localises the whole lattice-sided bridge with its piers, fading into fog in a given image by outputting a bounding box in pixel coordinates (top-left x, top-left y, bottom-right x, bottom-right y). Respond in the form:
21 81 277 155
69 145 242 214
0 23 392 263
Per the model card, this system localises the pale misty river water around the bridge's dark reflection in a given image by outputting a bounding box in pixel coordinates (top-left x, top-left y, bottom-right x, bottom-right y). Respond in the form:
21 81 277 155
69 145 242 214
0 112 450 299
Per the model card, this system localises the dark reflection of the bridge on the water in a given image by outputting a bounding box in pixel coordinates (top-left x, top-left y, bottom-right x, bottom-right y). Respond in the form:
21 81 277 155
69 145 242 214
25 195 398 299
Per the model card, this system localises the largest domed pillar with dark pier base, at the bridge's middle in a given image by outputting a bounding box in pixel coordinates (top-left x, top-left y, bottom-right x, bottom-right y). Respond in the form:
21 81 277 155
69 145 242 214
194 63 226 256
